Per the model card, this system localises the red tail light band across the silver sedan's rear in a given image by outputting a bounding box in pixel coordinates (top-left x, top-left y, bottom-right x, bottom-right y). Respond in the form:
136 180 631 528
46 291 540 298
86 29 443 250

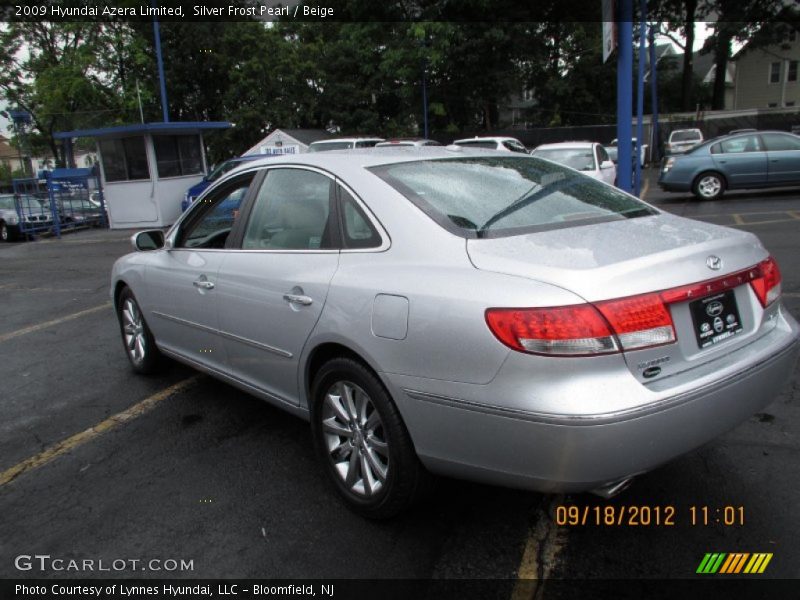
486 257 781 356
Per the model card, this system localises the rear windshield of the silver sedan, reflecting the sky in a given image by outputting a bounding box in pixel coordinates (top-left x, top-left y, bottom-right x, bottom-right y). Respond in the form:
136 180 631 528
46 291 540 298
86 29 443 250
370 156 657 238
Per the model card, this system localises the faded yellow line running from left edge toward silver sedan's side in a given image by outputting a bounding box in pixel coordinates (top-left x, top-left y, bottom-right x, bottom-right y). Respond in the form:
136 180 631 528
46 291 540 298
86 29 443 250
0 375 200 487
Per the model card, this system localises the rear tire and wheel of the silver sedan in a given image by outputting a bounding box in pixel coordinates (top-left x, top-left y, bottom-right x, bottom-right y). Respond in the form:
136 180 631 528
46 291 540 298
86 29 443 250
311 358 431 519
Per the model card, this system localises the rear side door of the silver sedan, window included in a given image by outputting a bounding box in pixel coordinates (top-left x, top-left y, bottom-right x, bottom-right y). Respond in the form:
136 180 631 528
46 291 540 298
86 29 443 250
218 166 339 404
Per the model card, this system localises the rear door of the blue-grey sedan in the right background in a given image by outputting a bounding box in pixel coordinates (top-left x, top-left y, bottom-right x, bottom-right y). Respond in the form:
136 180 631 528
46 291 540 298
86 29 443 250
711 134 768 188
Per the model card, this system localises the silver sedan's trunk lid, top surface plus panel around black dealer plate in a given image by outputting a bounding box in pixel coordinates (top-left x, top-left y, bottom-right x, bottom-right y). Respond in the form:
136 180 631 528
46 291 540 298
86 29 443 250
467 213 767 382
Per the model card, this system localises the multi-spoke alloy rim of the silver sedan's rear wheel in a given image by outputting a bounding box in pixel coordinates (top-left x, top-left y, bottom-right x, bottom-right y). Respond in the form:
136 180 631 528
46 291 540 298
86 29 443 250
322 381 390 498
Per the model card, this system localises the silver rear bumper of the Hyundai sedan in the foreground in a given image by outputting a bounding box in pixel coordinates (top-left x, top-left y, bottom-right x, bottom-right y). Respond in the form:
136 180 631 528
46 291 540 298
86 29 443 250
384 316 800 492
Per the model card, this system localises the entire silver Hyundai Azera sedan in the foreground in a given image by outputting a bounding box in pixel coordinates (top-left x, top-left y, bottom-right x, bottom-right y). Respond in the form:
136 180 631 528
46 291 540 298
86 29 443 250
112 147 798 517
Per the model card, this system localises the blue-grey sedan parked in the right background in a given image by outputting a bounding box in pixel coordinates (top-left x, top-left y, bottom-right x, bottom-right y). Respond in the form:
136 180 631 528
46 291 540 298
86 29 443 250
658 131 800 200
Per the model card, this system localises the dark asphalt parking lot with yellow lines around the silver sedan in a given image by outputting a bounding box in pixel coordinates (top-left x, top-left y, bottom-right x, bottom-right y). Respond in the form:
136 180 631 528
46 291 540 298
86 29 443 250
0 171 800 598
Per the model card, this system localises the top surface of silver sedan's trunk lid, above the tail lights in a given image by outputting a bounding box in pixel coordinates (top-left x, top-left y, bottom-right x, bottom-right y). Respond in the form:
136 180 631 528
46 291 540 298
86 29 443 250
467 213 767 305
